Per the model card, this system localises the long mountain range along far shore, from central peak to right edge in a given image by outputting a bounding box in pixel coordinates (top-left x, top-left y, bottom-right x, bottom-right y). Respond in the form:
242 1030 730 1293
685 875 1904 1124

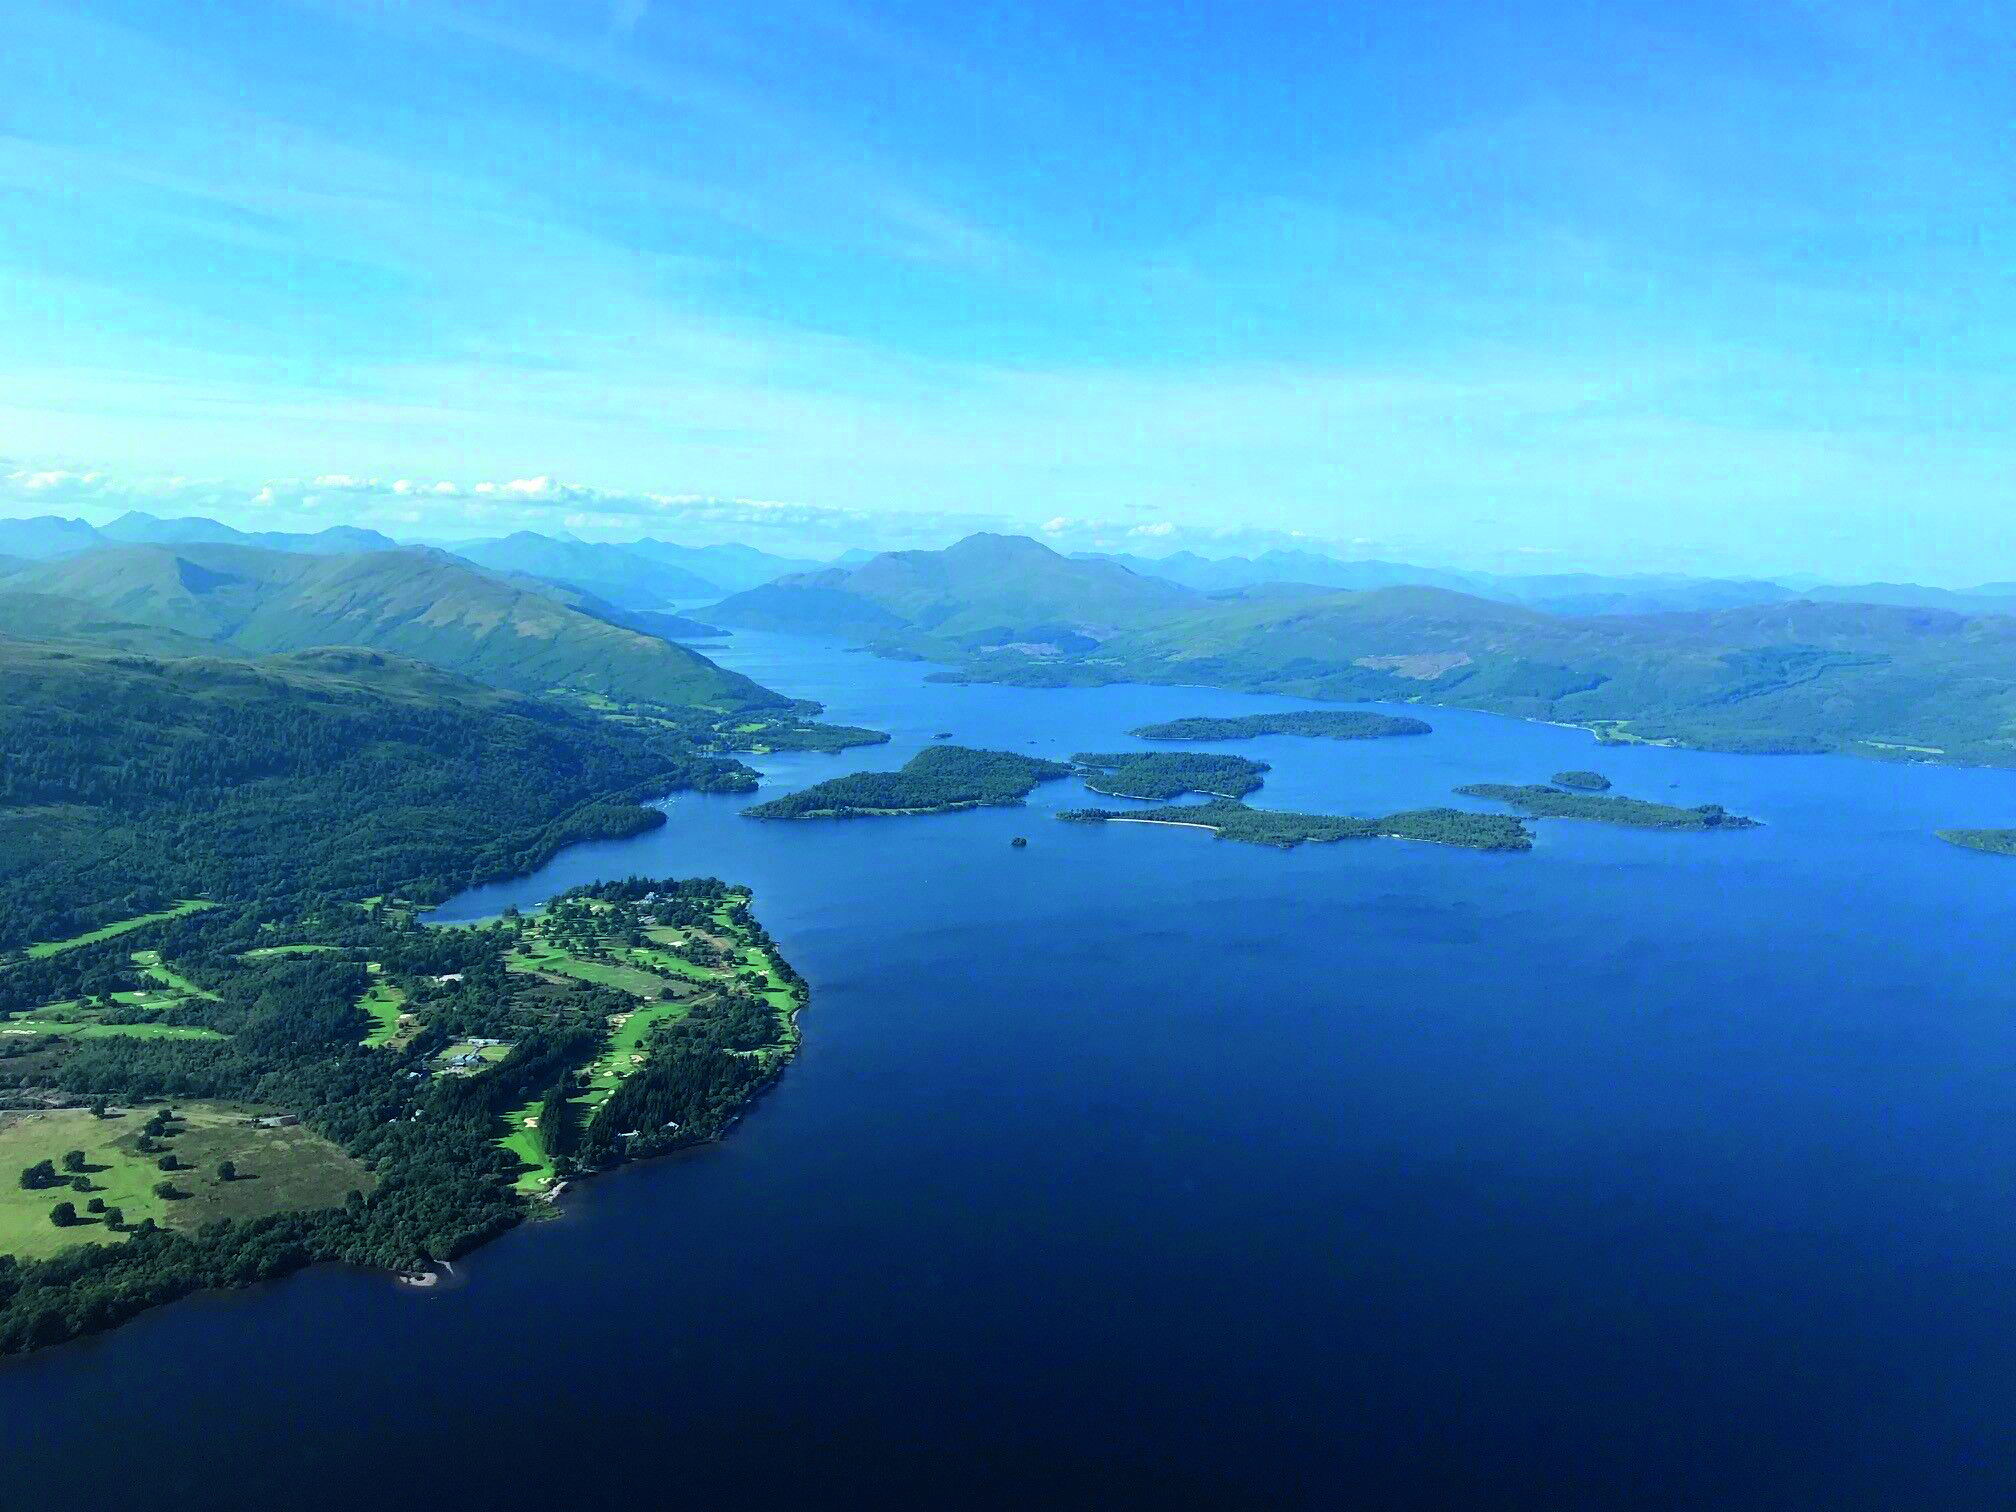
710 536 2016 766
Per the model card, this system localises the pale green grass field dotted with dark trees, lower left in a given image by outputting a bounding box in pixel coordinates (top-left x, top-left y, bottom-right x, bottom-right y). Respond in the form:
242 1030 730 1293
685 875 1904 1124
0 1103 373 1258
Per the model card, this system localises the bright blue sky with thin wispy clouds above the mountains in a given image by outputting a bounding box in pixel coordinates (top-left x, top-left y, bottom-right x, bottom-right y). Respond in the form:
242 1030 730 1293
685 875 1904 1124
0 0 2016 583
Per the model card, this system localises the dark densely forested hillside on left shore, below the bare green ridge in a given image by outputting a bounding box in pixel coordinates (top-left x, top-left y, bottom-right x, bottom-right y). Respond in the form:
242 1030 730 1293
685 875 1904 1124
0 639 756 948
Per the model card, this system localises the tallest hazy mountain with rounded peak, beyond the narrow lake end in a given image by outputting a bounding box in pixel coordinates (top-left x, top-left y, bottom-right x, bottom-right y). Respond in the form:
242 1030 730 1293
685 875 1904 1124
704 534 1200 651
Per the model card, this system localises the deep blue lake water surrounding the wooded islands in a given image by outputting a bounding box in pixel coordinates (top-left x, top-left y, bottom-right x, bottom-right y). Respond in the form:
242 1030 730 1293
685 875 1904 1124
0 637 2016 1508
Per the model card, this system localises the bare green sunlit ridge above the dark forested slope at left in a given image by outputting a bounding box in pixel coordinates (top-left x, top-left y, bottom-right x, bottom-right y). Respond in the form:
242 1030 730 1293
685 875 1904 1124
0 546 788 710
